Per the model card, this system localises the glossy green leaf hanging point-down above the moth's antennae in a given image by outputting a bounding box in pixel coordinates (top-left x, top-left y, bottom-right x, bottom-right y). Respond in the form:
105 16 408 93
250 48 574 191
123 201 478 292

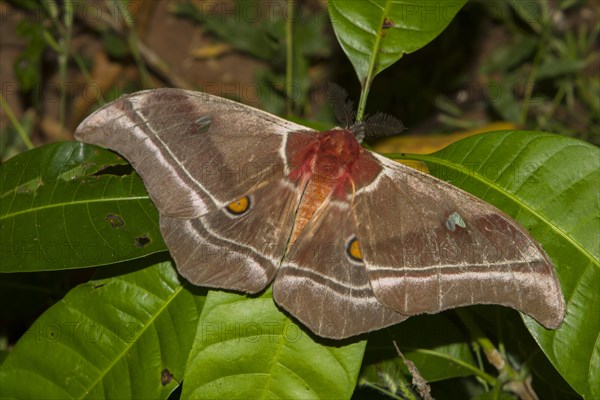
327 0 466 83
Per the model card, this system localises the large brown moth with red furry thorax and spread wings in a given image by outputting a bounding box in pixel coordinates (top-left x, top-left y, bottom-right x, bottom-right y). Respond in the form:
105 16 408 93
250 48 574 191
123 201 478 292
75 89 565 339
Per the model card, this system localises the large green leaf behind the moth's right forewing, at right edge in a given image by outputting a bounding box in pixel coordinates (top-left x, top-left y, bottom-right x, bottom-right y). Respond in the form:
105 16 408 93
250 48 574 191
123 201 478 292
411 131 600 399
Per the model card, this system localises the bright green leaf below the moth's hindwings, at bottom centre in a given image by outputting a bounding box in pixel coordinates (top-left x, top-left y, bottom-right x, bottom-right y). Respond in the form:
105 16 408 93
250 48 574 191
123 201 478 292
182 290 366 399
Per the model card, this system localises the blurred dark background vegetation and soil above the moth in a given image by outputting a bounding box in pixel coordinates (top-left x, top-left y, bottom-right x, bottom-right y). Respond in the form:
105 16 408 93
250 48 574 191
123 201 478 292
0 0 600 160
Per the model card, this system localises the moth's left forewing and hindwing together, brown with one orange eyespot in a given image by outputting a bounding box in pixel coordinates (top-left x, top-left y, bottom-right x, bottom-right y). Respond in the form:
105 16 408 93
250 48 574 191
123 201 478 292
75 89 307 293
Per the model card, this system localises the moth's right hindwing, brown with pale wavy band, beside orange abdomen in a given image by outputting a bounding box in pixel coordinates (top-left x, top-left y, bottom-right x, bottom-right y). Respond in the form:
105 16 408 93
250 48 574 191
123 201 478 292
273 200 407 339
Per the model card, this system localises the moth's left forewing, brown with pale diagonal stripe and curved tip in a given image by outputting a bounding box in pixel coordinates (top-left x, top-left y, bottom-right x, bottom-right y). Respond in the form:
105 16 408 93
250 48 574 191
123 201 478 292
75 89 306 218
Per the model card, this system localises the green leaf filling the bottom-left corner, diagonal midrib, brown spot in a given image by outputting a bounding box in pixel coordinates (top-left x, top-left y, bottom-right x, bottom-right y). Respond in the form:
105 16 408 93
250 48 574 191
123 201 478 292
0 263 204 399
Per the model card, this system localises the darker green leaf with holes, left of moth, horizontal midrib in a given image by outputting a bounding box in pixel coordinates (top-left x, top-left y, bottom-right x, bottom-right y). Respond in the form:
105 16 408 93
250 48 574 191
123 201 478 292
0 142 166 272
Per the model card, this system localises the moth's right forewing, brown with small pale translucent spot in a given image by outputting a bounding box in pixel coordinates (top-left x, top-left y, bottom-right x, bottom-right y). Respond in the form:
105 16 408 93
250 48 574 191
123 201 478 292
354 155 565 328
